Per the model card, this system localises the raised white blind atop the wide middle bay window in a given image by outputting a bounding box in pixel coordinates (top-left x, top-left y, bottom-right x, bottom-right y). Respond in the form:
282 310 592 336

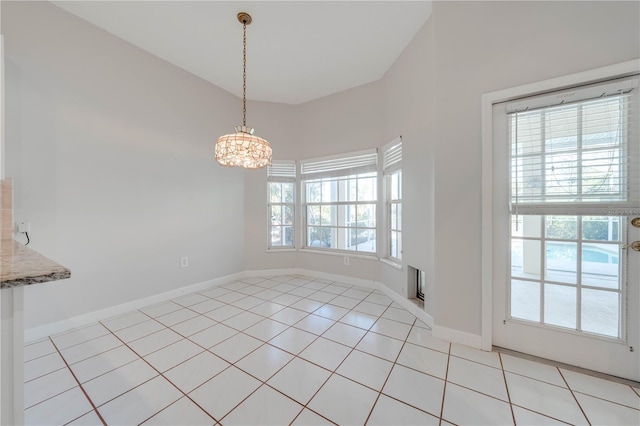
300 149 378 179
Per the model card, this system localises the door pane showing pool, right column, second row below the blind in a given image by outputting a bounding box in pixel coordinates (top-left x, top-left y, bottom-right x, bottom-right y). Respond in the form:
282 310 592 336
582 243 620 289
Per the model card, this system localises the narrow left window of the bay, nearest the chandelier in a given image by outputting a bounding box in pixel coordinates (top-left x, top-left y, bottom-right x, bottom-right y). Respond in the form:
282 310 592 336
267 161 296 249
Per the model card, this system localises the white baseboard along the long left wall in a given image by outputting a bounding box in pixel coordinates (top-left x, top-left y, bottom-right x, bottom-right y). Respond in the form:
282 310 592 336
24 272 246 343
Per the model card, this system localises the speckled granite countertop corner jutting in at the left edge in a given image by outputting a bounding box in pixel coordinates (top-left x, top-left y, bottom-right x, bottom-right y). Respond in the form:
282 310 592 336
0 240 71 289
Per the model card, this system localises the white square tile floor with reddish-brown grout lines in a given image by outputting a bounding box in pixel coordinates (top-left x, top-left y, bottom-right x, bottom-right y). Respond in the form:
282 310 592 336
25 276 640 425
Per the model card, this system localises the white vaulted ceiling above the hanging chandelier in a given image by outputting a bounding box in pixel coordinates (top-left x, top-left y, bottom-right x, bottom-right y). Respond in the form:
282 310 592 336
53 1 431 104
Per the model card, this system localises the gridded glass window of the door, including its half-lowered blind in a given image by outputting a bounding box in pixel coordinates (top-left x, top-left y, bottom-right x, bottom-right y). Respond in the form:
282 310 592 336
506 77 640 338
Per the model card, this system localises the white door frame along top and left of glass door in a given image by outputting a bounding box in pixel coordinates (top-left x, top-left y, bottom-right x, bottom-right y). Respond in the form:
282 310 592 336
481 58 640 351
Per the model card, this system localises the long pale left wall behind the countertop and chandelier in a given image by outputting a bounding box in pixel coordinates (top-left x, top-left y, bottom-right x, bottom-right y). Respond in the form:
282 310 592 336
2 1 244 328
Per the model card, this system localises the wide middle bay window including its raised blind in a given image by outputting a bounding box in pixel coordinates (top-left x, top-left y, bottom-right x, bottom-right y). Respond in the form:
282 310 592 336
300 150 378 254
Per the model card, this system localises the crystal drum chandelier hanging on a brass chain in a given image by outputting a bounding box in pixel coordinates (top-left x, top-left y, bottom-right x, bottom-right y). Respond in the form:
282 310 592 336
216 12 271 169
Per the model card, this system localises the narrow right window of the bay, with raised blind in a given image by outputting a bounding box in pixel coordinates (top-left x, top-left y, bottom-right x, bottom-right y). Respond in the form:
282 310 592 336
383 138 402 262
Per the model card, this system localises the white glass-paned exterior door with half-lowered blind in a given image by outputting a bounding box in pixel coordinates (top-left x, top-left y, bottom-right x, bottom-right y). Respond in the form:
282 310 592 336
493 77 640 380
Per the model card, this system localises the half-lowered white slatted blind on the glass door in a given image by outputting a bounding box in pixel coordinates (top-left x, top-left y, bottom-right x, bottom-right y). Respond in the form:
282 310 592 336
507 78 640 215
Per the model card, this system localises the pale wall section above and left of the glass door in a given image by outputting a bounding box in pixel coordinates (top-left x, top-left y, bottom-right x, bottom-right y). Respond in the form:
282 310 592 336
432 1 640 335
